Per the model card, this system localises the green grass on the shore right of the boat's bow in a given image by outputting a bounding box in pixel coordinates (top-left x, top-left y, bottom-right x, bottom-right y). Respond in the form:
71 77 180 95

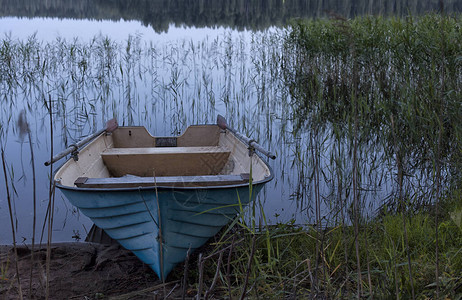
186 198 462 299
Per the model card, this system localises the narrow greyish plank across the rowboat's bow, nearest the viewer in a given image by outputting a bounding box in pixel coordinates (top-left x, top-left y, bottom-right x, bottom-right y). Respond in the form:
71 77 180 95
74 173 249 188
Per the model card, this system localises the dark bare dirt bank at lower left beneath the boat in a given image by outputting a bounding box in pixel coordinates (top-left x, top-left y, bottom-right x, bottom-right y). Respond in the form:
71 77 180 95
0 243 184 299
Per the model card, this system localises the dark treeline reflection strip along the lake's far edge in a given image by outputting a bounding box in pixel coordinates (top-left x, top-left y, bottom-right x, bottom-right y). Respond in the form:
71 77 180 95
0 0 462 32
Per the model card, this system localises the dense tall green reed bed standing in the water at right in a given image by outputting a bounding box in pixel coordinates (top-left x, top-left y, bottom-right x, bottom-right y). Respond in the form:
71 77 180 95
283 14 462 298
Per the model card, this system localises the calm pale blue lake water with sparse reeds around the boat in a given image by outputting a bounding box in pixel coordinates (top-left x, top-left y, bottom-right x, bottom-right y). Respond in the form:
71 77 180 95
0 0 462 244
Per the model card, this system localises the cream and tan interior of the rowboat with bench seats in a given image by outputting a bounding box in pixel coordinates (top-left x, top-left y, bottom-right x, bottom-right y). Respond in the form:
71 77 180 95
55 125 270 188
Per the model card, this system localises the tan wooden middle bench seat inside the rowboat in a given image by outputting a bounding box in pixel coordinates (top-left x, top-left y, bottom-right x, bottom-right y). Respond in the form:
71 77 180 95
101 146 231 177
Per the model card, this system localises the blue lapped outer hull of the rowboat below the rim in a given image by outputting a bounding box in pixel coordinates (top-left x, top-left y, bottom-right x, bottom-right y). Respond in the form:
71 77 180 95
58 183 264 278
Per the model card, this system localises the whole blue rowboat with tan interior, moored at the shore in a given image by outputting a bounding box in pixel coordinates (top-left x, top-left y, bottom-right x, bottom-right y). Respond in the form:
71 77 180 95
51 116 274 279
